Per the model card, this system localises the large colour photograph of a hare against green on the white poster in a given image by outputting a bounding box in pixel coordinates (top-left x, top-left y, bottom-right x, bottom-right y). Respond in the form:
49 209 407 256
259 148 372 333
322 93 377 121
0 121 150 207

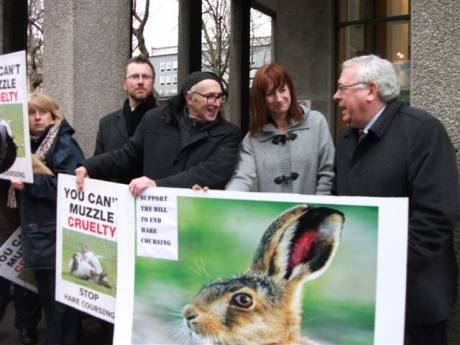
132 196 379 345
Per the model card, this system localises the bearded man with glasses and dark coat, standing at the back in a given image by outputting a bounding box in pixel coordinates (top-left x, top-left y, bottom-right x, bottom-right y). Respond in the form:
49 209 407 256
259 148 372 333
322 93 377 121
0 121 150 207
94 56 156 183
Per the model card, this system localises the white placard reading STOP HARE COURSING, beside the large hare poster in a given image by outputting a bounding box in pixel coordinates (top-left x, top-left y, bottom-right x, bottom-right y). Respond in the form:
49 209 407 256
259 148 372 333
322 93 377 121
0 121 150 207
56 174 135 322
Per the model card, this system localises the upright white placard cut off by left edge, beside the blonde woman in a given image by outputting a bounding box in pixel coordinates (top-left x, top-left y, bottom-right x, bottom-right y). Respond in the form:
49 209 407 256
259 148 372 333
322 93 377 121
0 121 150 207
0 51 33 183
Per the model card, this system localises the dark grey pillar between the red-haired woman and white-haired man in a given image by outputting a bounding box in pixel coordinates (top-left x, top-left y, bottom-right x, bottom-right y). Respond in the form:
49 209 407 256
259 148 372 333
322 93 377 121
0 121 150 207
274 0 335 124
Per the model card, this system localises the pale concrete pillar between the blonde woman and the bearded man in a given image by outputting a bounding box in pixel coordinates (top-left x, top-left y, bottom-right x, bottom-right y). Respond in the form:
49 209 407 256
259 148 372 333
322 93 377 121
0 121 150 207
43 0 131 156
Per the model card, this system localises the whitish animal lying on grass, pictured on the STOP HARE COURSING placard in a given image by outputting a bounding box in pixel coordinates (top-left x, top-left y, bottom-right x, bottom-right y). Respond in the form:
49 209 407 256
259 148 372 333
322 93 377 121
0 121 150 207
69 245 113 289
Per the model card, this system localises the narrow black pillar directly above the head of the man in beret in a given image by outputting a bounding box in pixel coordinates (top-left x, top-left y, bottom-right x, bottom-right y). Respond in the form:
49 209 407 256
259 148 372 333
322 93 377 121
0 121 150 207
177 0 202 85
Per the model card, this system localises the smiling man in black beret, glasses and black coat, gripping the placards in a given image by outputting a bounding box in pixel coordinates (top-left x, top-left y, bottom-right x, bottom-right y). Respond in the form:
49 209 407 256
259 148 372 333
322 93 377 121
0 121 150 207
75 72 240 196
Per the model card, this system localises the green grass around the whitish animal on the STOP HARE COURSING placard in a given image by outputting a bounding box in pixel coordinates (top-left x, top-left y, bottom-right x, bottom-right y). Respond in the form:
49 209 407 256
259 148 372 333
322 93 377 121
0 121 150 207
62 229 117 297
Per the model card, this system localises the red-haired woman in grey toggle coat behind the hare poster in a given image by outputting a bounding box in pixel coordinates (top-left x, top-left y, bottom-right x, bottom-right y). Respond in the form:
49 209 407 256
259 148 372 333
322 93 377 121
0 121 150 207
226 63 334 194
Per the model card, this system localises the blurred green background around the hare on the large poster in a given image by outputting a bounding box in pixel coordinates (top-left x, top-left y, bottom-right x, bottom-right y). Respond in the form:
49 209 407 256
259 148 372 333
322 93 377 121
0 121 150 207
133 197 378 344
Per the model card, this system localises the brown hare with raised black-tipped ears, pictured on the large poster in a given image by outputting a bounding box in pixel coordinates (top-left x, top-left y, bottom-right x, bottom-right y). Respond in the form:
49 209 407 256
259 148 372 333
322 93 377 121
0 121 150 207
182 205 345 345
